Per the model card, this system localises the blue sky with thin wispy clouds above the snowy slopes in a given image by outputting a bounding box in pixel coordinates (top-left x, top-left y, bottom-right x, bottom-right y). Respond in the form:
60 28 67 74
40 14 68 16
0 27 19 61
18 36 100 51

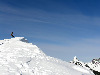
0 0 100 61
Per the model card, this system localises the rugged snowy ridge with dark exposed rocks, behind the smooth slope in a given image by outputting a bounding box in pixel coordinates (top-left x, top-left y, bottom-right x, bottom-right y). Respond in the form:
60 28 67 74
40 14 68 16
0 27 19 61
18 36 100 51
70 56 100 75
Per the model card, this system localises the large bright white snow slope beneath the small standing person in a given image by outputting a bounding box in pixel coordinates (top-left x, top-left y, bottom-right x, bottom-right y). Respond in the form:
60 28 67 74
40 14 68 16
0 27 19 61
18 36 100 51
0 37 94 75
